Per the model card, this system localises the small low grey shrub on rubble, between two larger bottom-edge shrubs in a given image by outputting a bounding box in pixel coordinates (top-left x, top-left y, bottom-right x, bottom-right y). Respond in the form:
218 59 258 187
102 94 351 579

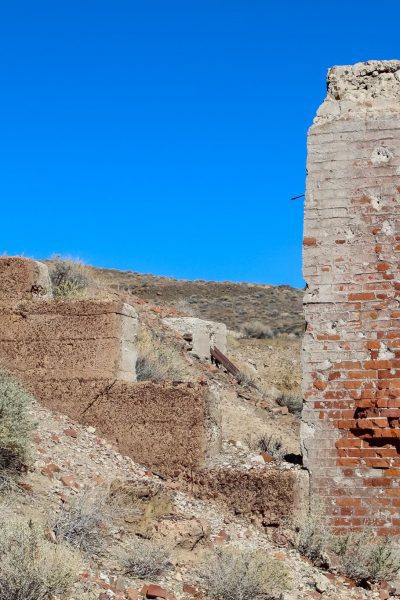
124 537 169 579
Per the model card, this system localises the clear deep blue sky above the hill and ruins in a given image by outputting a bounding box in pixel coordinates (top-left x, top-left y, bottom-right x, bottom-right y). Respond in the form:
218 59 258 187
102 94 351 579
0 0 400 286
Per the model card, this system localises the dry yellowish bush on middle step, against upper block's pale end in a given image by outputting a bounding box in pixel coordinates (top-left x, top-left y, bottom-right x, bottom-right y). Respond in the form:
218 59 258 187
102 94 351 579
136 326 185 381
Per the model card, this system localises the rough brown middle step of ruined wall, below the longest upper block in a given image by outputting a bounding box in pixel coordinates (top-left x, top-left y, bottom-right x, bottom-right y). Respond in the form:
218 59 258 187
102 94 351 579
29 378 221 473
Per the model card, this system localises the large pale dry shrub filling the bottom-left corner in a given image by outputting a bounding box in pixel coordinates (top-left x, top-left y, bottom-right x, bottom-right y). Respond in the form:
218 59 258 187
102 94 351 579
0 512 79 600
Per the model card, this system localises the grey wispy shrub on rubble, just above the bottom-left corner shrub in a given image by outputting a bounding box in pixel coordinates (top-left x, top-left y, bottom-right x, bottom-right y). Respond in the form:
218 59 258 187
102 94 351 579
49 492 112 554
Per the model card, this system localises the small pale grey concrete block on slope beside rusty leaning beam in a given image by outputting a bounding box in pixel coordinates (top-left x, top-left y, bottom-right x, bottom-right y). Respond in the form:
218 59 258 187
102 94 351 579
163 317 227 360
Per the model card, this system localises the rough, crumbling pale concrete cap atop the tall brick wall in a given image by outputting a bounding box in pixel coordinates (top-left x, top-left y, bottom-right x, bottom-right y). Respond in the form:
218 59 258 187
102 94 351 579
314 60 400 125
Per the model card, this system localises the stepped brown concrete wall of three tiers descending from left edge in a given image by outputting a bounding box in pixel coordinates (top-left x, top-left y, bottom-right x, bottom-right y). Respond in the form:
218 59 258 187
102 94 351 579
0 257 220 472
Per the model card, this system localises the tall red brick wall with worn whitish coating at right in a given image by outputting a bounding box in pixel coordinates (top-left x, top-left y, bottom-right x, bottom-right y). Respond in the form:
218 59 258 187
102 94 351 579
302 61 400 536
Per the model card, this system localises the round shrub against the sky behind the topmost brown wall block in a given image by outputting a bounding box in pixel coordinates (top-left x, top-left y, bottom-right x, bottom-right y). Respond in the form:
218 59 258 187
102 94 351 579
50 256 89 299
